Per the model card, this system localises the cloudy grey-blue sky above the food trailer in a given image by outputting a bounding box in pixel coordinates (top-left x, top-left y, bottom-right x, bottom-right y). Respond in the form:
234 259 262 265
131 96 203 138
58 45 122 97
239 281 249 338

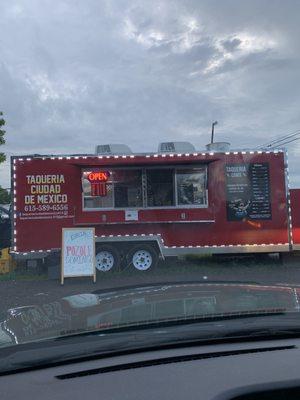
0 0 300 187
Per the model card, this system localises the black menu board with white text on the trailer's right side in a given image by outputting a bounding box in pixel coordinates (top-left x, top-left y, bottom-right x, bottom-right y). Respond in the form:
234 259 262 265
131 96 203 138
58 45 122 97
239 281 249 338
225 163 272 221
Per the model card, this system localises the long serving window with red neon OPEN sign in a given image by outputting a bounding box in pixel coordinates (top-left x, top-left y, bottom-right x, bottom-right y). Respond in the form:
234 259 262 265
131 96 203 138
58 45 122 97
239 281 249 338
82 166 207 210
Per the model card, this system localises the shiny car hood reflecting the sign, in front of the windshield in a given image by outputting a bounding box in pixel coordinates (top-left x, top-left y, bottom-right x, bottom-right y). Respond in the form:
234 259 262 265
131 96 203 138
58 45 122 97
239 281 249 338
0 282 299 347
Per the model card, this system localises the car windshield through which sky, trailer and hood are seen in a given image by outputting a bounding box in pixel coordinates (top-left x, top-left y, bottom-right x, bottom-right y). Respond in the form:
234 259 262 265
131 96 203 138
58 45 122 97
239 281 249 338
0 0 300 370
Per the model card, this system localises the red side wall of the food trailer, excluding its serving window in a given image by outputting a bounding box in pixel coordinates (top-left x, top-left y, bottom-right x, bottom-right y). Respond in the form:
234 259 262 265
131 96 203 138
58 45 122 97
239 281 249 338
12 152 288 252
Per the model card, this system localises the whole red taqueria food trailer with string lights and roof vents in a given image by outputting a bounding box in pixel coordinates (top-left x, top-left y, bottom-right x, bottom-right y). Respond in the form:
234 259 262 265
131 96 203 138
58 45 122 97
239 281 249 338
11 142 300 271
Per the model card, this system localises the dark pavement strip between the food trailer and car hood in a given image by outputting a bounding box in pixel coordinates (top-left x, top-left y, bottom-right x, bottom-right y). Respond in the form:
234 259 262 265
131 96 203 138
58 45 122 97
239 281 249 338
0 256 300 312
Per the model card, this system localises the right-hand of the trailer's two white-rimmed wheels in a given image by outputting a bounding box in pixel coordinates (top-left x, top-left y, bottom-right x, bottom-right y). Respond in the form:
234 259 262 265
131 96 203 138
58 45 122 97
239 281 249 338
128 244 158 271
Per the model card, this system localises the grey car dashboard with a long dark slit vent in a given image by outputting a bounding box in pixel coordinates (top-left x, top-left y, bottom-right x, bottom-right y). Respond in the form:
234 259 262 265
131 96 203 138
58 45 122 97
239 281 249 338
0 339 300 400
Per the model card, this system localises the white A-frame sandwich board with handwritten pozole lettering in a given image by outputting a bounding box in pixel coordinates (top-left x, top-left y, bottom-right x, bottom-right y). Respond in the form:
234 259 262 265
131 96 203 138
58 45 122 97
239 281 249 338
61 228 96 285
